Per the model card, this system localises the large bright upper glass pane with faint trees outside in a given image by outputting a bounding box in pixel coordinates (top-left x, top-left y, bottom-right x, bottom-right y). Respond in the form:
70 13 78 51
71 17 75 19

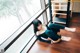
0 0 41 44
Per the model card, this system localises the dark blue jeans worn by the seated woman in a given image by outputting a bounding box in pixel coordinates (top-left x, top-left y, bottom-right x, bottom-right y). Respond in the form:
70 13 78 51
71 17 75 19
45 24 65 41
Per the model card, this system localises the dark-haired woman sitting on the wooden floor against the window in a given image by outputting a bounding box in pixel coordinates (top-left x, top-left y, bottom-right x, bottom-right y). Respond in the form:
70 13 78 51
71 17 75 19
33 19 76 43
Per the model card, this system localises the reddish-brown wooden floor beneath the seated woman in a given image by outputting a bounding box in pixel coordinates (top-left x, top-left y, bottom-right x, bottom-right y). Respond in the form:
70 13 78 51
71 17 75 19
29 14 80 53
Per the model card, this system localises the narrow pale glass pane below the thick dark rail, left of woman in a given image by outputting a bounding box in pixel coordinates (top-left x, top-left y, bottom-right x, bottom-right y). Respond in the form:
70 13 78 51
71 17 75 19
5 25 34 53
